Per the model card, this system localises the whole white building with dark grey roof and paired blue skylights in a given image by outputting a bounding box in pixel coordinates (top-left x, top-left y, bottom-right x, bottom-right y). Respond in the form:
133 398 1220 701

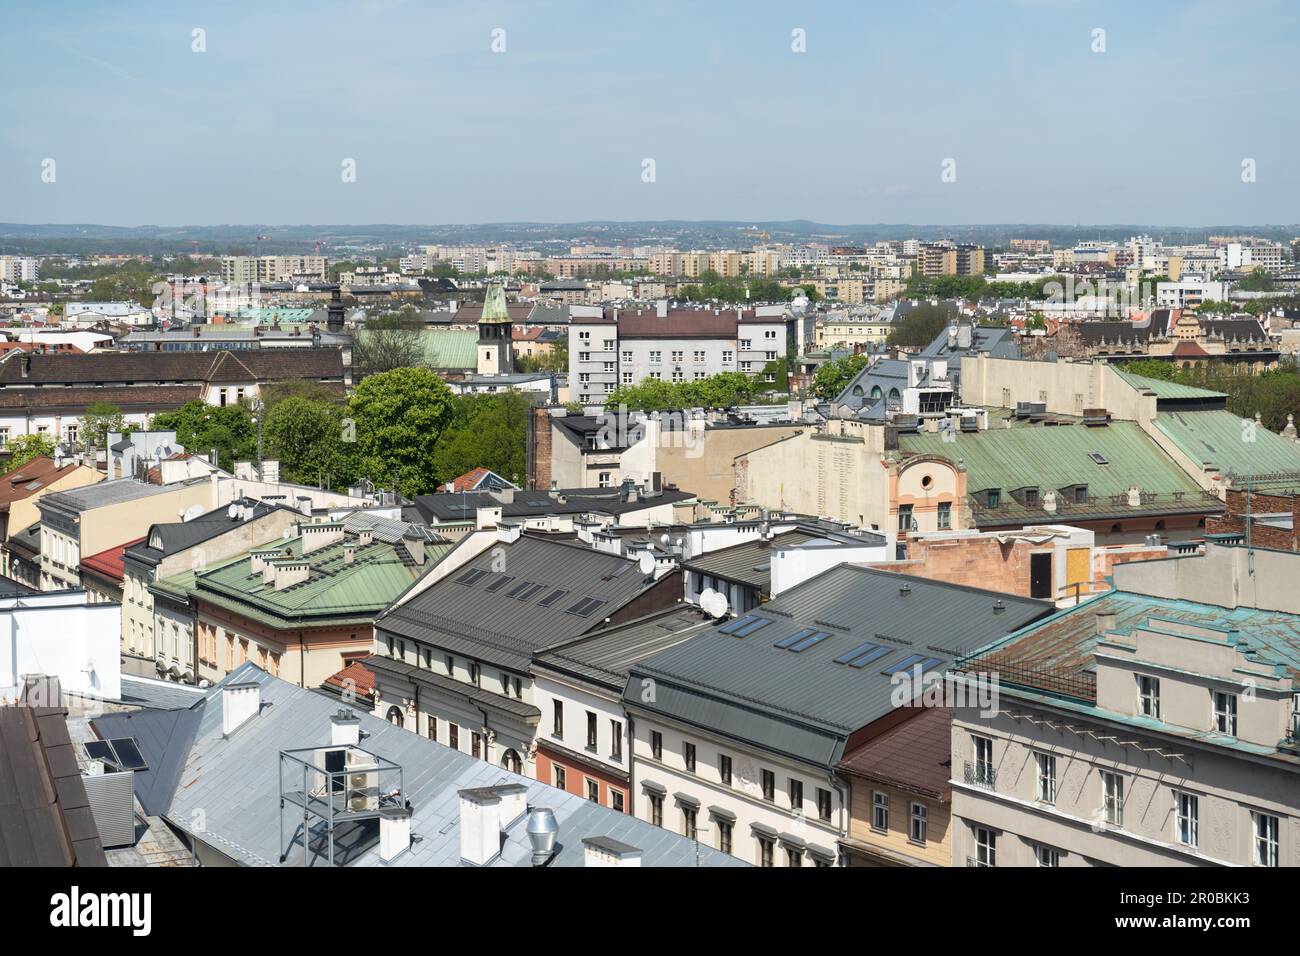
623 564 1052 866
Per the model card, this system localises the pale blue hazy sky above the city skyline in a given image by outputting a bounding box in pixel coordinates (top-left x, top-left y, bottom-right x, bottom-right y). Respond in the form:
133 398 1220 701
0 0 1300 226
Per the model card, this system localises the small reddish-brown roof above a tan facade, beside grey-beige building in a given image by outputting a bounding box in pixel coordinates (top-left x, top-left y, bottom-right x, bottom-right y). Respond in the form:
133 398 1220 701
839 708 953 800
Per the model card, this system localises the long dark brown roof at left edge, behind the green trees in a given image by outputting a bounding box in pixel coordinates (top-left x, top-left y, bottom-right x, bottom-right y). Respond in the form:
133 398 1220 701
0 349 343 385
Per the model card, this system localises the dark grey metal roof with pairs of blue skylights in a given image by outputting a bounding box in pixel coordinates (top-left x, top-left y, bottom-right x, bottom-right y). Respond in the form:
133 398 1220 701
624 564 1053 769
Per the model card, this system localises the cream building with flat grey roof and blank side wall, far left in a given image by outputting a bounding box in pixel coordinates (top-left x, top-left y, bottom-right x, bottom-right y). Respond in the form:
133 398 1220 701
36 479 213 591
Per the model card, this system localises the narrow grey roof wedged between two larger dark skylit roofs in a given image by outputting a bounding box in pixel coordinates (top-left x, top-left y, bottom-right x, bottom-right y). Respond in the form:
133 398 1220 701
533 605 711 693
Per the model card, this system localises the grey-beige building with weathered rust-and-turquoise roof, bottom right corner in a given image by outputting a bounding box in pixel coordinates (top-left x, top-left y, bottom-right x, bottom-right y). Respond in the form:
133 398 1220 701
952 544 1300 868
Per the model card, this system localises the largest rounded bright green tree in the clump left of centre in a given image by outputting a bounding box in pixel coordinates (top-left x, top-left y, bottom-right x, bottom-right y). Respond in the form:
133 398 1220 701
347 368 454 497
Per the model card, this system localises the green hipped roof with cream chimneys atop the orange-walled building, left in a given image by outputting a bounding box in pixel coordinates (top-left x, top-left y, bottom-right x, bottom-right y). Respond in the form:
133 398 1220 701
153 536 452 628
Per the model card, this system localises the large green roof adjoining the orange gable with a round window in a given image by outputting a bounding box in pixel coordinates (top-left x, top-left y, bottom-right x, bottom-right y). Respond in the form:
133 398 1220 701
898 421 1201 498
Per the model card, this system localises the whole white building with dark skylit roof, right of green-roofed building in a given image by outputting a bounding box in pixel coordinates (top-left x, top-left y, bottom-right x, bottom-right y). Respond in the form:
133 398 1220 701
365 525 681 777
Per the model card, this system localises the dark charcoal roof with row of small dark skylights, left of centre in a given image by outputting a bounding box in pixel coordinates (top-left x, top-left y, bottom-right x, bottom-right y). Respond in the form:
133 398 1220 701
376 533 655 670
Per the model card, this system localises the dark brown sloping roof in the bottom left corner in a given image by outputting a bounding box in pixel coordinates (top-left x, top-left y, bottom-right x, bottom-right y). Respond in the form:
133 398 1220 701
0 706 108 866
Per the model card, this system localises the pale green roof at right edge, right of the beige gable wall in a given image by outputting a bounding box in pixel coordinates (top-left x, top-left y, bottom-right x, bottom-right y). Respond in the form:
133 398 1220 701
1156 408 1300 488
